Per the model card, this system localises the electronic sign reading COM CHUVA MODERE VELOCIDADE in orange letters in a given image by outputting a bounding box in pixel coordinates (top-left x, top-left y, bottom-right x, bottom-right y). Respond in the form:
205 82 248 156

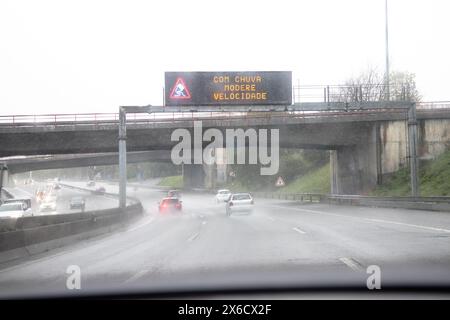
165 71 292 106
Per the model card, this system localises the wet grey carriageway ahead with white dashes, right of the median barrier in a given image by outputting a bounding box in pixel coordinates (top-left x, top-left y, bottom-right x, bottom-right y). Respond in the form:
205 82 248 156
0 187 450 295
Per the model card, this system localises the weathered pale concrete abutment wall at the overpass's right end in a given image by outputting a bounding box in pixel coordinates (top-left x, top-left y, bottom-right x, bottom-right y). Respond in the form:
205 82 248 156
330 119 450 194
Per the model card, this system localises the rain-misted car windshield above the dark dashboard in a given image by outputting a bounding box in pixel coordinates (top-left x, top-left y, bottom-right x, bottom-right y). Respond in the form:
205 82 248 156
0 0 450 298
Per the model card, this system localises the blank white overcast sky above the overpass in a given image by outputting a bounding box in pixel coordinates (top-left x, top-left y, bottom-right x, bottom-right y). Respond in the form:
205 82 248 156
0 0 450 114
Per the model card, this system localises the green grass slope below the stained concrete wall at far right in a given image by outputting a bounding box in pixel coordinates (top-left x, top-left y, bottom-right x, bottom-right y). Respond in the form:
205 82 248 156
371 150 450 197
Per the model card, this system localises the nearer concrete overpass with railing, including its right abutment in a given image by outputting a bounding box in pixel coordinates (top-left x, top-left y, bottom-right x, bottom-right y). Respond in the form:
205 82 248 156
0 101 450 194
